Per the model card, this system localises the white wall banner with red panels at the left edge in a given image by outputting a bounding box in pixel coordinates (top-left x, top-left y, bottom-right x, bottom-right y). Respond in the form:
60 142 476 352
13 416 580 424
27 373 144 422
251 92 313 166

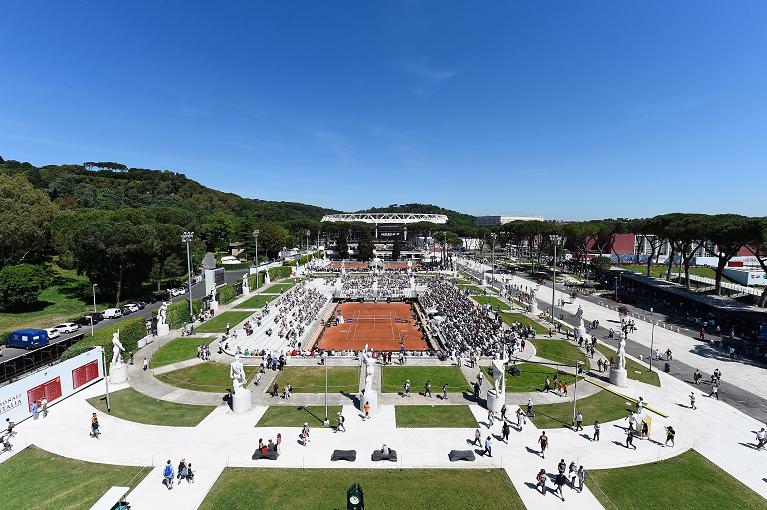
0 348 104 428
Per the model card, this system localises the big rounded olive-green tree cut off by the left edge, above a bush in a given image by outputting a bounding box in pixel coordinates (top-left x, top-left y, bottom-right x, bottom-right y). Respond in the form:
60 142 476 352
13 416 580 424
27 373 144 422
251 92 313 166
0 174 57 267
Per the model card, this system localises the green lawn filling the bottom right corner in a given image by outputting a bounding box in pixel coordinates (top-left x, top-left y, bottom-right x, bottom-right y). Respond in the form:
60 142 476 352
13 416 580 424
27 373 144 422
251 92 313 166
586 450 767 510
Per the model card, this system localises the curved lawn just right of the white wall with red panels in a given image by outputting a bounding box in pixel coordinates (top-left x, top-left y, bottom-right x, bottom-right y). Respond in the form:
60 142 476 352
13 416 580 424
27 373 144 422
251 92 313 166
88 388 215 427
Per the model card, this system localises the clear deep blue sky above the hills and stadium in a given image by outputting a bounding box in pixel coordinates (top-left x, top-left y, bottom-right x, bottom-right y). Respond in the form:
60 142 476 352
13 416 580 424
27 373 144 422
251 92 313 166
0 0 767 219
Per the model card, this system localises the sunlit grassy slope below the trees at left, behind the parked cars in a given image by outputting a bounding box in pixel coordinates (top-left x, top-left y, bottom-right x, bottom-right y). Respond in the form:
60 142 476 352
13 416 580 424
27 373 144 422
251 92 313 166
0 265 93 339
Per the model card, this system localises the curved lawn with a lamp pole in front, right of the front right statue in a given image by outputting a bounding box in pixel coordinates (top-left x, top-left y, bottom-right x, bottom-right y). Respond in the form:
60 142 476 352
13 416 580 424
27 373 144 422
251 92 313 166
532 383 634 429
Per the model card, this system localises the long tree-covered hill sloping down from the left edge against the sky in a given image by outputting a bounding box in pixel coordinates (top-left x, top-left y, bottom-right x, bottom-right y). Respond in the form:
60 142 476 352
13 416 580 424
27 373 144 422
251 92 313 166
0 158 339 222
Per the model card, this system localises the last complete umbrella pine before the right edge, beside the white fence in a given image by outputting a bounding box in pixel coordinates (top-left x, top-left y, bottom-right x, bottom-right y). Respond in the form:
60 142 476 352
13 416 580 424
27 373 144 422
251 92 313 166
705 214 758 294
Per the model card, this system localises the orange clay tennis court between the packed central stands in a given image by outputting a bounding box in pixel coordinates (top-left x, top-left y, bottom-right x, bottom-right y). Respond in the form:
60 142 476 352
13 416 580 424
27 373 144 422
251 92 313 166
319 303 429 351
